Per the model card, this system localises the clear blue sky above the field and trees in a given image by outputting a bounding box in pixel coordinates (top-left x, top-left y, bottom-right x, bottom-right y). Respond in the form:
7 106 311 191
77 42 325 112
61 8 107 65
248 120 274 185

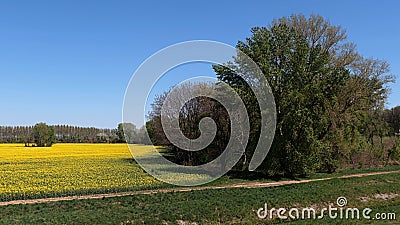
0 0 400 128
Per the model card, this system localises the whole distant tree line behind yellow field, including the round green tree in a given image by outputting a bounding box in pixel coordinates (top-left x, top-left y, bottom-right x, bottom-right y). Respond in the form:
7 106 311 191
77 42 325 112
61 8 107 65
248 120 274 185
0 123 145 146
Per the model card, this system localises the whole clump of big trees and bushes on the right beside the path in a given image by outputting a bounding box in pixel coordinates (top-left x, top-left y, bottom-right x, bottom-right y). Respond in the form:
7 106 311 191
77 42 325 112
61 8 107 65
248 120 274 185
146 15 400 177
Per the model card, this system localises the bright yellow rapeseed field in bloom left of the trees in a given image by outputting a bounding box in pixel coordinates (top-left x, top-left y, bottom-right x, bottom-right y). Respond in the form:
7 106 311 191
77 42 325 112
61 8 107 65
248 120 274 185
0 144 163 201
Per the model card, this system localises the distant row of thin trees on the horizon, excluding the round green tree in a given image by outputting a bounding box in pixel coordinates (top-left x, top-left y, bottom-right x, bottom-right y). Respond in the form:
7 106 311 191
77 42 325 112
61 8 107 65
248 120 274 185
0 123 149 144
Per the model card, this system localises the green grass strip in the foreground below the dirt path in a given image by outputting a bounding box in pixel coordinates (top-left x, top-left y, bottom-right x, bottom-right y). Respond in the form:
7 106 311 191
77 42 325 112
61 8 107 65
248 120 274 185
0 173 400 224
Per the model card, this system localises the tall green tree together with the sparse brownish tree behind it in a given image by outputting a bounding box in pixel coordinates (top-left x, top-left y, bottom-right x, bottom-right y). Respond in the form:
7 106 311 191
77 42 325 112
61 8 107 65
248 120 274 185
214 15 392 176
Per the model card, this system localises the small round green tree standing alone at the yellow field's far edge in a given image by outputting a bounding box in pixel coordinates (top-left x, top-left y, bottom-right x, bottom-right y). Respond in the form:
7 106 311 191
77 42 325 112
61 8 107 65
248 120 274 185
32 123 56 147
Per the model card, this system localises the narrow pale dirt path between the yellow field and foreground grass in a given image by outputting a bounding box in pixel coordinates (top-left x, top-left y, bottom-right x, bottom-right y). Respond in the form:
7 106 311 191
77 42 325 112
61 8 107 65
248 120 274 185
0 170 400 206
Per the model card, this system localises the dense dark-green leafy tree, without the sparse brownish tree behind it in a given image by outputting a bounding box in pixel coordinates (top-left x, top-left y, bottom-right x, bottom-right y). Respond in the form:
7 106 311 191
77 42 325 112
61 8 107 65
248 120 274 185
214 21 349 176
